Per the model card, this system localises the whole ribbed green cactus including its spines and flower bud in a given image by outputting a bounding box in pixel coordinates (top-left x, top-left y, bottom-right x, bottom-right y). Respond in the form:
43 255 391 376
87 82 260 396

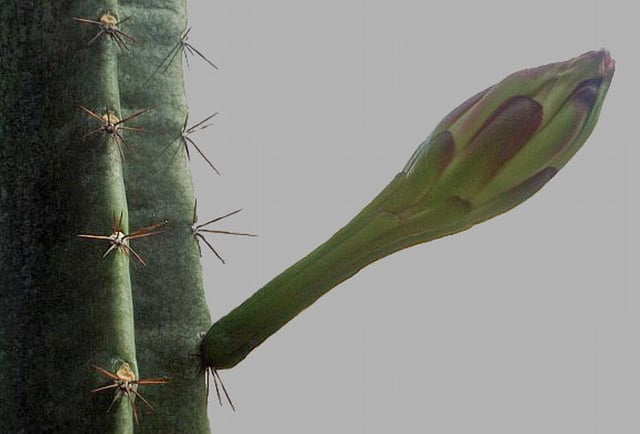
0 0 613 433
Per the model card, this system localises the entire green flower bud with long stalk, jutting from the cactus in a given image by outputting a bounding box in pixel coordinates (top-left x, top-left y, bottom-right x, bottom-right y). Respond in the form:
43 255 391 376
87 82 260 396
201 50 615 369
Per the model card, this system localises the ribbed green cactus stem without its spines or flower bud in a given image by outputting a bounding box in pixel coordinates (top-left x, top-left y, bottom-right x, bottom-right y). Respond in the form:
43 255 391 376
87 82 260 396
0 0 211 433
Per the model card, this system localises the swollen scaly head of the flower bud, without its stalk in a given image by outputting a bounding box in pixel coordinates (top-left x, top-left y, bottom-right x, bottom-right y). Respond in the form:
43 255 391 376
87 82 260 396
365 50 614 247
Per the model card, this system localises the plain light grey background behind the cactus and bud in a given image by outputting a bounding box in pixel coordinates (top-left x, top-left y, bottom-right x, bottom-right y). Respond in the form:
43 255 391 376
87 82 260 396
182 0 640 434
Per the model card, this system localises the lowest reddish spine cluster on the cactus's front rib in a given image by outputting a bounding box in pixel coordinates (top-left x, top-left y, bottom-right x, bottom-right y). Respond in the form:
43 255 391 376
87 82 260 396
91 363 169 424
